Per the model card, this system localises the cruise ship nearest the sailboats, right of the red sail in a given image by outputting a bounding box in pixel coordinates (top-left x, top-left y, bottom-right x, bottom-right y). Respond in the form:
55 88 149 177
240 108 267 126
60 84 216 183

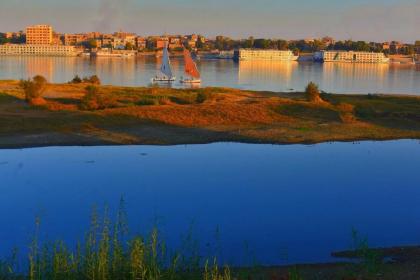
234 49 299 61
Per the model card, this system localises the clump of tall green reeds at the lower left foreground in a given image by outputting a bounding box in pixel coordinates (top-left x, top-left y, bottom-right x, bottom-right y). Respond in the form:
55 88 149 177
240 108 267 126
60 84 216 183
0 199 231 280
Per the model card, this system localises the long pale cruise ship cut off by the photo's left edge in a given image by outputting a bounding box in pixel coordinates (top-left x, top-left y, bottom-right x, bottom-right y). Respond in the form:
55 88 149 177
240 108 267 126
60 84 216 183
0 44 81 56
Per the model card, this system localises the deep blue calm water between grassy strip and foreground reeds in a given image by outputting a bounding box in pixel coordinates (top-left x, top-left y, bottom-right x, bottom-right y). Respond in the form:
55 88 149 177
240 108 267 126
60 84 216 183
0 141 420 264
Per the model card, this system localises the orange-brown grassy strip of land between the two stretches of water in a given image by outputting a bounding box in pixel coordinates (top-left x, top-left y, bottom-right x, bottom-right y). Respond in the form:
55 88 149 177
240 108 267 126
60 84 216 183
0 81 420 148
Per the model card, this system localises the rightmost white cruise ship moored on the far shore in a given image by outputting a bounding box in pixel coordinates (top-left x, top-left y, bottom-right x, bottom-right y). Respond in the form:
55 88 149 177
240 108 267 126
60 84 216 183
314 51 389 63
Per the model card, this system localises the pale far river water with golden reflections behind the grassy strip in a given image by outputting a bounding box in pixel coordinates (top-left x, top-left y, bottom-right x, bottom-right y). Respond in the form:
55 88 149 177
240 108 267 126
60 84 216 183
0 57 420 94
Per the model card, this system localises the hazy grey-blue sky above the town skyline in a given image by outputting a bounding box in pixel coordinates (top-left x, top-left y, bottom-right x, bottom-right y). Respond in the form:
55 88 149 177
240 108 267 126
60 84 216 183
0 0 420 42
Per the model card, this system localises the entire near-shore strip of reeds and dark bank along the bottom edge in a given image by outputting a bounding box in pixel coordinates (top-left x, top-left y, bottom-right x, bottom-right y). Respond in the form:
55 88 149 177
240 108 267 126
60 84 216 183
0 198 420 280
